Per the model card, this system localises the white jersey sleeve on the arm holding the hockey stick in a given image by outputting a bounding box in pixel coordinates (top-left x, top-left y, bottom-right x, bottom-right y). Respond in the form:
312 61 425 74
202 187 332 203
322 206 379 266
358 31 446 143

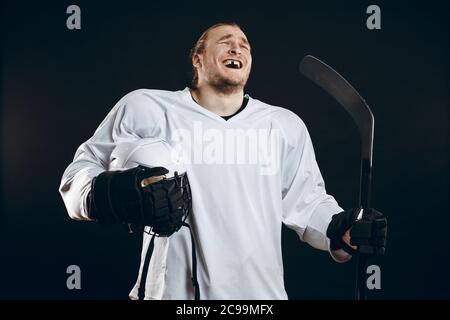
281 110 351 262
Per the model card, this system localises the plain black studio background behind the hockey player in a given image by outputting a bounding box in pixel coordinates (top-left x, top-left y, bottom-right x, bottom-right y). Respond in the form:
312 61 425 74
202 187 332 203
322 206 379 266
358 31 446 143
0 1 450 299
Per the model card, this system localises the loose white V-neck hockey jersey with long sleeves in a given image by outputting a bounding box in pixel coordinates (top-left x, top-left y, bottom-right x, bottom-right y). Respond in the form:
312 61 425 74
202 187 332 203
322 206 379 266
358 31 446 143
59 88 350 299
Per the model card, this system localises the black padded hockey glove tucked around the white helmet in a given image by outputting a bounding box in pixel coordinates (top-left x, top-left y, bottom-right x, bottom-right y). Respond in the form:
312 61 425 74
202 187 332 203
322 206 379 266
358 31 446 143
89 166 190 236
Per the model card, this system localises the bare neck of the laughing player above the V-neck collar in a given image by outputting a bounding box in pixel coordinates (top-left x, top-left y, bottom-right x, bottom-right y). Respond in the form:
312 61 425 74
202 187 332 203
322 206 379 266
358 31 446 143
192 86 244 116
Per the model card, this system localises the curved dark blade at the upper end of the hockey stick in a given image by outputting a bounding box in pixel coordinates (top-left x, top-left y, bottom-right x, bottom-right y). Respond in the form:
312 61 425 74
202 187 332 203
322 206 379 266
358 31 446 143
300 55 374 163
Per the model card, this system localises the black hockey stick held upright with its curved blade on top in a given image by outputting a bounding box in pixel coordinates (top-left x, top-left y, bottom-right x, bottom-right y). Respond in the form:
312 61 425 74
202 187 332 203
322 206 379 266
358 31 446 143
300 55 374 300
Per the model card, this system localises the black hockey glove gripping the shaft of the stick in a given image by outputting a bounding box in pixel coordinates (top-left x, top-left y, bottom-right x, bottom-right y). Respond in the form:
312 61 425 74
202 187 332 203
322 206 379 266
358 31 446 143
327 208 387 255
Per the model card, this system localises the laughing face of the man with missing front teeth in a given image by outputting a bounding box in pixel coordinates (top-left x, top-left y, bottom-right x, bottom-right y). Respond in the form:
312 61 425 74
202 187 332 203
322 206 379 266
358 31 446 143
193 26 252 92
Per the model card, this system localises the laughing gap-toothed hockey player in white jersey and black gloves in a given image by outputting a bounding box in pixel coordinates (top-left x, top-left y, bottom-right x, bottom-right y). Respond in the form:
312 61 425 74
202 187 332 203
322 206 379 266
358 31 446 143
59 23 385 299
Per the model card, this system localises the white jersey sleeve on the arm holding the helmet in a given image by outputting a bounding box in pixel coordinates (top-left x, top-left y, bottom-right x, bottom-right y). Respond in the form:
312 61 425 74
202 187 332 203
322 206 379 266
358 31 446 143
59 92 161 220
